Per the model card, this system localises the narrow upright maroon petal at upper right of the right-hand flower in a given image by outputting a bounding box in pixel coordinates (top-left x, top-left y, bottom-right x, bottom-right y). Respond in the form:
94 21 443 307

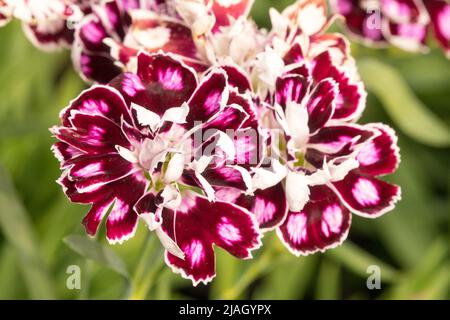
306 79 337 132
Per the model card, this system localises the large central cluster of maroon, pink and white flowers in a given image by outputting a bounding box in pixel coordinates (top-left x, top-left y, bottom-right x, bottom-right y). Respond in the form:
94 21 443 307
47 0 400 285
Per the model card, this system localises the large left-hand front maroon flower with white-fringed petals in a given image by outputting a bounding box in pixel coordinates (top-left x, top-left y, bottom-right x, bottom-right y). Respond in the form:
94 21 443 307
51 52 261 285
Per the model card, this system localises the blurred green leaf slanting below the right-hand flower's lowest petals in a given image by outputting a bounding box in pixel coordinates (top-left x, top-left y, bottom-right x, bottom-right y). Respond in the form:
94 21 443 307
325 240 399 282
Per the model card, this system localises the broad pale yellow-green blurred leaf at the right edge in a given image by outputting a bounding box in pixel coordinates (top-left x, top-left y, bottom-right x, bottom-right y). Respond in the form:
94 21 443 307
358 58 450 147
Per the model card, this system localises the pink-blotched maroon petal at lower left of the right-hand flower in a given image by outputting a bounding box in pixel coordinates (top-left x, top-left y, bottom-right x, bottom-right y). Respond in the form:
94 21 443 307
235 183 288 231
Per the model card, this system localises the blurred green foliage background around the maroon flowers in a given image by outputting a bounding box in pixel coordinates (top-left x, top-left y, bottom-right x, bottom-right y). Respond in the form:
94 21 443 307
0 0 450 299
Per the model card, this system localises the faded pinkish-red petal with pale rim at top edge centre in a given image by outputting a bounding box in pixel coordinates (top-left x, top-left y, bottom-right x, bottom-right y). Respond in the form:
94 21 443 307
211 0 254 31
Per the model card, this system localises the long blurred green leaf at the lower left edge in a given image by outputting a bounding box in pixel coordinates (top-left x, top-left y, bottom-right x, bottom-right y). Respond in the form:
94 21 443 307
0 167 54 299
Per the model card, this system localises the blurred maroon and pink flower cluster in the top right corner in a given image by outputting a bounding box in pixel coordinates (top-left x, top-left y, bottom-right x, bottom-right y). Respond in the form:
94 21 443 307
332 0 450 58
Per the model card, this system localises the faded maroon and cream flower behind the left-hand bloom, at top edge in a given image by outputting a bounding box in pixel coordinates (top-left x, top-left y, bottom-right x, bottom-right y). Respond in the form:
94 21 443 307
72 0 258 83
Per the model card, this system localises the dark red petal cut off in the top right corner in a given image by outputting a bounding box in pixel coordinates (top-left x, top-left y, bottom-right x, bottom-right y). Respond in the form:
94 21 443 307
424 0 450 57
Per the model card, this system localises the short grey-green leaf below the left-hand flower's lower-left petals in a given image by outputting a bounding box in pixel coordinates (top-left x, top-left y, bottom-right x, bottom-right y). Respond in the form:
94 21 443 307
63 235 129 279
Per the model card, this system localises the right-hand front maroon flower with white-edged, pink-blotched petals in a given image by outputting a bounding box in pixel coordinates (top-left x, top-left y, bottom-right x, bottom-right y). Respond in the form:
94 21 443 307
220 67 400 256
